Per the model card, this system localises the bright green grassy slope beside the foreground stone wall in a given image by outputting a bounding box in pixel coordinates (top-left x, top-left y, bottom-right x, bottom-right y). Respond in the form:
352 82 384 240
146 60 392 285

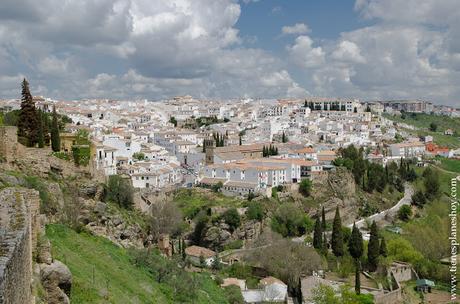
46 224 228 304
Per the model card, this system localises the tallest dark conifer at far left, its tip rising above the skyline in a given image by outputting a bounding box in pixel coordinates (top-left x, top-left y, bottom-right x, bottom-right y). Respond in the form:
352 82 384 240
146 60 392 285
18 78 39 147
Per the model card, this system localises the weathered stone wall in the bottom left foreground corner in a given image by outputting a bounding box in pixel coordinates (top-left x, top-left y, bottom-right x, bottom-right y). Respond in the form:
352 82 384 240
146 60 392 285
0 188 40 304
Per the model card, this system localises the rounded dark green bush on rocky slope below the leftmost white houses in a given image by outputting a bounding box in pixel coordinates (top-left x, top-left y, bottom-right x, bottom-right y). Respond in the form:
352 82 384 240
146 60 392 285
106 175 134 209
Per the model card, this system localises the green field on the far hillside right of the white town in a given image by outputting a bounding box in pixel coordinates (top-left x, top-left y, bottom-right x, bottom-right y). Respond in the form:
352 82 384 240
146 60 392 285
384 113 460 148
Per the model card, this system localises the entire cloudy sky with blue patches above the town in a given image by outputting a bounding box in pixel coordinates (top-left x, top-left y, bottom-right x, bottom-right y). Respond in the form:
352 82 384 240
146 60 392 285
0 0 460 106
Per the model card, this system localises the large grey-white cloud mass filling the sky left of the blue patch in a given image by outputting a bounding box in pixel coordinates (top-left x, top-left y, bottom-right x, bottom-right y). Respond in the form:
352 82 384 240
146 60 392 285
0 0 301 99
